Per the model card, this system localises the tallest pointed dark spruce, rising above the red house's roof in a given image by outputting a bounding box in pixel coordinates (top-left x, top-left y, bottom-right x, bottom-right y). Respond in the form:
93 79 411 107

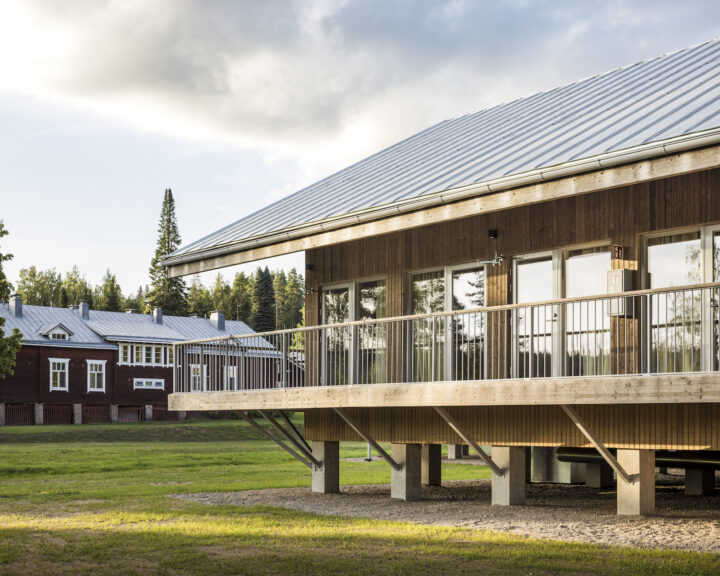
146 188 188 316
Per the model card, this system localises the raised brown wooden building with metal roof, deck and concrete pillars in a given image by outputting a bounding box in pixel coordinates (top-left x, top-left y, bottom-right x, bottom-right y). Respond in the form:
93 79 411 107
166 41 720 514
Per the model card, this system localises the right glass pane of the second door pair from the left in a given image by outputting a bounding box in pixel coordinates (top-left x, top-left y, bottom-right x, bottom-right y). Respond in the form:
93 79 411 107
449 267 487 380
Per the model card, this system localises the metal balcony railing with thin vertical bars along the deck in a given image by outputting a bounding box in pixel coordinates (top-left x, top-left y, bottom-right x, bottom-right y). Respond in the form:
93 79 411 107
174 283 720 393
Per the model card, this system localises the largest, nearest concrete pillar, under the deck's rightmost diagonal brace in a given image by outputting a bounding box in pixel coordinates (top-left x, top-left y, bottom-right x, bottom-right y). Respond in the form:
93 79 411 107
617 450 655 516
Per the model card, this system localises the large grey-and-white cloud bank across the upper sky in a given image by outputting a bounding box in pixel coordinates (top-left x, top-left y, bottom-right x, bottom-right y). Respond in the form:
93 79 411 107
0 0 720 182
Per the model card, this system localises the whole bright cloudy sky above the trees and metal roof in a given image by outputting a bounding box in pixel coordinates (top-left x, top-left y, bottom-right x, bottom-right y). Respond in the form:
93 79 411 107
0 0 720 294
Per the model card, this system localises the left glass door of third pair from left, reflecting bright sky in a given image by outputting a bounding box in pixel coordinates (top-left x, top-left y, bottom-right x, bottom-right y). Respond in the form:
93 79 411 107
514 255 555 378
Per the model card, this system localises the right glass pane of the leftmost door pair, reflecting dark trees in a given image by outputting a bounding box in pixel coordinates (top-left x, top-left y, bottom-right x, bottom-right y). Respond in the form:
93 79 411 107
355 280 391 384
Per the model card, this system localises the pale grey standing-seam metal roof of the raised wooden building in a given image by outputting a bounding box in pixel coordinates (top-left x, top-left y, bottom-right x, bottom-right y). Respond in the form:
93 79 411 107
167 39 720 264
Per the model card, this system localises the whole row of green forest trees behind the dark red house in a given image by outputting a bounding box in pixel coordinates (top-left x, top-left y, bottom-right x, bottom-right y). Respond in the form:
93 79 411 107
0 189 305 331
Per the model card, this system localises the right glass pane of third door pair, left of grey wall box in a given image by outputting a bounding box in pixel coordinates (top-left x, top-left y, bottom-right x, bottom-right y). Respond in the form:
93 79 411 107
564 246 610 376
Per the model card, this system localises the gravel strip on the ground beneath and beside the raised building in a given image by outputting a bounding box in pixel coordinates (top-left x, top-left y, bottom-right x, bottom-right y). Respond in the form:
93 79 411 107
176 480 720 554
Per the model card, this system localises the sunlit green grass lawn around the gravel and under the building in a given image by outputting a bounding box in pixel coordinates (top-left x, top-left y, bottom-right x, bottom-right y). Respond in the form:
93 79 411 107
0 421 720 575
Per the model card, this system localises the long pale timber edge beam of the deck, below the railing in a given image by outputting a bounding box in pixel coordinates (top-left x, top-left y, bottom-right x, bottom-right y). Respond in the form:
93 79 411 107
168 373 720 411
